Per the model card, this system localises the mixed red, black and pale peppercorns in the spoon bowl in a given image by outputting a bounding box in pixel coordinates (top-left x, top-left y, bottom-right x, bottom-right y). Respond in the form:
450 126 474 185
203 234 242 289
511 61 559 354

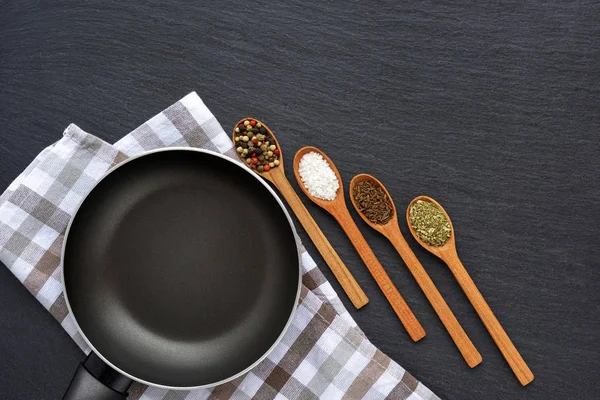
234 119 280 172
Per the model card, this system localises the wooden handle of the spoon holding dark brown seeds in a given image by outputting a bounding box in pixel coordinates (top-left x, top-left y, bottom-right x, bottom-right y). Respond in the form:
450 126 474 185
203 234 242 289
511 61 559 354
388 229 481 368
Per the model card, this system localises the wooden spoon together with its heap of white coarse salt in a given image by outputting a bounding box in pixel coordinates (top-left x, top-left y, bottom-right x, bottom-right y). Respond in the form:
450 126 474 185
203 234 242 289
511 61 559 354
294 147 425 342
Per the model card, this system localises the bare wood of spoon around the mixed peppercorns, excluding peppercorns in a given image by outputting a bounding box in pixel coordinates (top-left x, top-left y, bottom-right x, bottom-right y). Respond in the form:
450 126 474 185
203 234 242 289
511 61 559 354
232 117 369 309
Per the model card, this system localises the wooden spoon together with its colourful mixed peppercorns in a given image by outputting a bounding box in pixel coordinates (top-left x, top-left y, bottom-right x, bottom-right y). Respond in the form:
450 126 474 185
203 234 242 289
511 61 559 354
232 118 369 309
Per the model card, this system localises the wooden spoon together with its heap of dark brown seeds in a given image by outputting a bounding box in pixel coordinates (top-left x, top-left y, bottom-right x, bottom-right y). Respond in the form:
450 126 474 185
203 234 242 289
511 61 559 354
350 174 481 368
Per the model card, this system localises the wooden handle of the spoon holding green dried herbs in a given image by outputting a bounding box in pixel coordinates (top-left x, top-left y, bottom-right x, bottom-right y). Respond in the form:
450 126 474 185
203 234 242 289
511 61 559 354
445 252 534 386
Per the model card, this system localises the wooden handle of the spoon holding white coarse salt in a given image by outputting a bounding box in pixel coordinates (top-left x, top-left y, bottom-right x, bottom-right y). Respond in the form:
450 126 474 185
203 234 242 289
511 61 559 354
332 205 425 342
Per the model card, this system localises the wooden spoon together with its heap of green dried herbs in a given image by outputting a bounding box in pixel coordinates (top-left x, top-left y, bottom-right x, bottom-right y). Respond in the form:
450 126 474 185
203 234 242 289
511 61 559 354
406 196 534 386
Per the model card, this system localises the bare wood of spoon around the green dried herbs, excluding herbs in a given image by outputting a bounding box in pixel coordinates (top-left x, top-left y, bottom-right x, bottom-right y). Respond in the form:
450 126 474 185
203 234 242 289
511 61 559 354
406 196 534 386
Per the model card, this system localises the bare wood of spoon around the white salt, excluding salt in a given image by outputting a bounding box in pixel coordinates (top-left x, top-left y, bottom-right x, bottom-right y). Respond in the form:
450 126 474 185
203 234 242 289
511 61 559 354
294 147 425 342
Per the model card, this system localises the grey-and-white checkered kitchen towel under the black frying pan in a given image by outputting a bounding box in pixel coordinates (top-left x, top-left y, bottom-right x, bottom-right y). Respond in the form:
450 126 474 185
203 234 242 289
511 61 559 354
0 93 438 400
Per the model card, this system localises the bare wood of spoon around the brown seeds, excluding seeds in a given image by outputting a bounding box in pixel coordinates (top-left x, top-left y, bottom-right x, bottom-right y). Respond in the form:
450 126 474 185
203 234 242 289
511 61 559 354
350 174 481 368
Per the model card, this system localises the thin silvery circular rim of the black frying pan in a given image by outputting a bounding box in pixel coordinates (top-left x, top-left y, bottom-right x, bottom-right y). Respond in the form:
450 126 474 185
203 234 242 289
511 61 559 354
60 147 302 390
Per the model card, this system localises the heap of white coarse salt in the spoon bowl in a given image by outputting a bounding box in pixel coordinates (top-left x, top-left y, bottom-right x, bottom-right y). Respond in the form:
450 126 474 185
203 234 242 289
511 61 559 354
298 151 340 200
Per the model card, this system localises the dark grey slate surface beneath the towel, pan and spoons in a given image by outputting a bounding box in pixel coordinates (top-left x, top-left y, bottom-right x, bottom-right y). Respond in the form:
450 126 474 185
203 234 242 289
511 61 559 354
0 0 600 399
